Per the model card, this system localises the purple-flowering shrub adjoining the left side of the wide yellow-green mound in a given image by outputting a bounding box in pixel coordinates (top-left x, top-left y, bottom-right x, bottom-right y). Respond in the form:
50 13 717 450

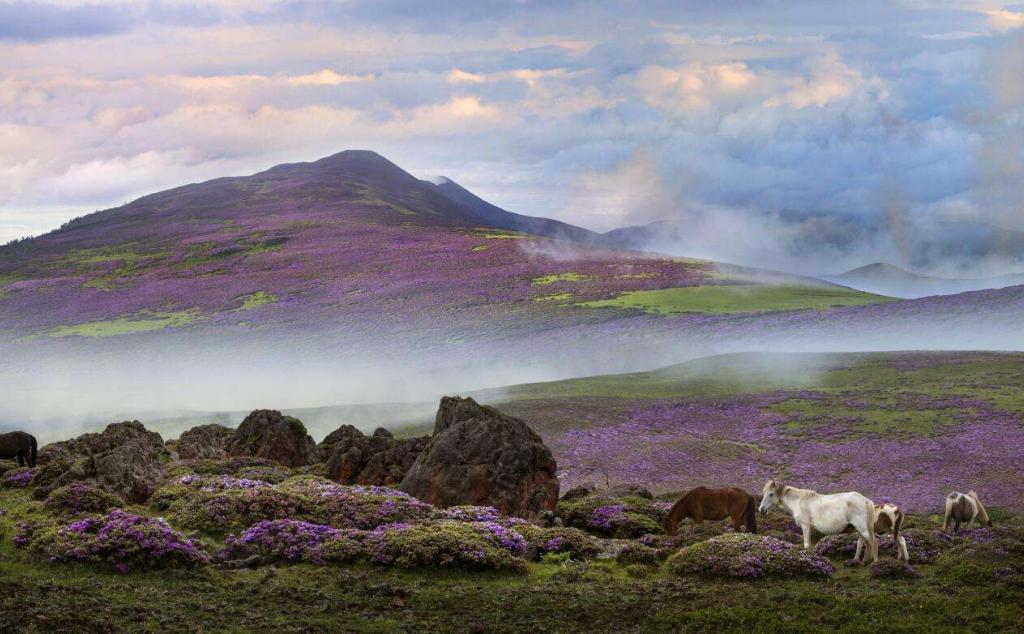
217 519 362 563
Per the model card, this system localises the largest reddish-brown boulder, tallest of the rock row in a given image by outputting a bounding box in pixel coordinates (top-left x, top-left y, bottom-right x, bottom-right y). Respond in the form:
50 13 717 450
399 396 558 517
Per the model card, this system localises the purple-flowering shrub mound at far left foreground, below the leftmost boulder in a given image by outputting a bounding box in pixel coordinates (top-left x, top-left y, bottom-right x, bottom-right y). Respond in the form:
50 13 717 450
20 509 210 573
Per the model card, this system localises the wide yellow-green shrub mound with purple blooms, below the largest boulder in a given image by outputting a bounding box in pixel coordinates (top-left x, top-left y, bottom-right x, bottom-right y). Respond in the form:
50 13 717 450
364 521 525 570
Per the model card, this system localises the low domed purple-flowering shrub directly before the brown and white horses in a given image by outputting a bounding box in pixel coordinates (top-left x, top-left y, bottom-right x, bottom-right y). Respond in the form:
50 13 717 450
668 533 836 579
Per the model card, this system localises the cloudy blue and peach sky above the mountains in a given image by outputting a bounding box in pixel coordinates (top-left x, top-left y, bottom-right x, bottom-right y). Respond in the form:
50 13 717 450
0 0 1024 276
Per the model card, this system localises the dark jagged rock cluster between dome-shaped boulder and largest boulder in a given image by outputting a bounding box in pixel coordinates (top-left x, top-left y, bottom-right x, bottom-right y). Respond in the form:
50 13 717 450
321 425 429 485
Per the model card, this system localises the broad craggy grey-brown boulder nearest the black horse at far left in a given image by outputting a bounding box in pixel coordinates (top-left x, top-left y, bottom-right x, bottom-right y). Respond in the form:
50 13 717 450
36 421 171 503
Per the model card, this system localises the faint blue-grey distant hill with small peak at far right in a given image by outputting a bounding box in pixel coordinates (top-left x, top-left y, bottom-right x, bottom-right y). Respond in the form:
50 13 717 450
823 262 1024 298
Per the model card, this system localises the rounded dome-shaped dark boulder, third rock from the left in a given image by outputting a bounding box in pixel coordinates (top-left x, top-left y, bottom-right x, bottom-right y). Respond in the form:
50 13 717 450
226 410 319 467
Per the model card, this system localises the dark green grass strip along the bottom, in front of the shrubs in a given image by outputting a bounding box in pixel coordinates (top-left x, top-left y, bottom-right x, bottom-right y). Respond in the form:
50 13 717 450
0 483 1024 632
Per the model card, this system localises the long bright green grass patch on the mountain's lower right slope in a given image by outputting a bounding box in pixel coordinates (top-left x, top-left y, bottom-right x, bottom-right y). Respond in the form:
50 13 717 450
578 285 893 314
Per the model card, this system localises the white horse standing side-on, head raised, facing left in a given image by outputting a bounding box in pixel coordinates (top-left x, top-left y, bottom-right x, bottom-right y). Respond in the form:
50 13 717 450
760 480 879 563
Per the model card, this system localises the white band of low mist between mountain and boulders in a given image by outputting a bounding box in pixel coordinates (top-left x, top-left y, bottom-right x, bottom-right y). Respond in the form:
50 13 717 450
8 291 1024 441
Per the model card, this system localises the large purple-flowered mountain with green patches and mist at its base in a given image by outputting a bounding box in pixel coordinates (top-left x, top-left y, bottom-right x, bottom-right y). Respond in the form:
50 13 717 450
8 152 1024 427
